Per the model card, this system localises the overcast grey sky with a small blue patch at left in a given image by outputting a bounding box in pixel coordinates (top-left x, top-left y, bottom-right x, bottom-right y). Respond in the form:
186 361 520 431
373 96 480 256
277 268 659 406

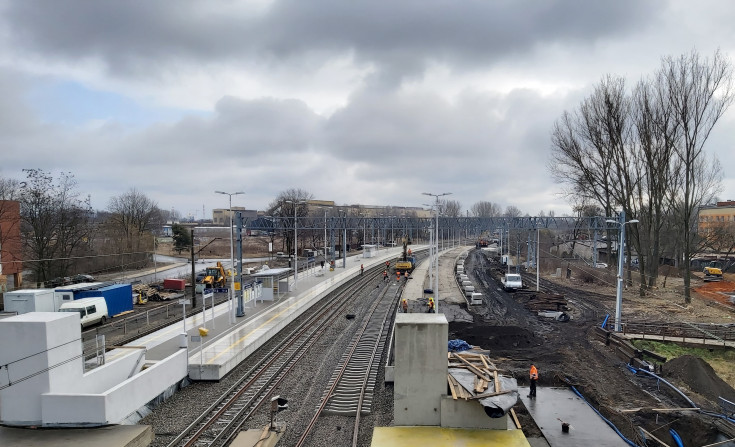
0 0 735 219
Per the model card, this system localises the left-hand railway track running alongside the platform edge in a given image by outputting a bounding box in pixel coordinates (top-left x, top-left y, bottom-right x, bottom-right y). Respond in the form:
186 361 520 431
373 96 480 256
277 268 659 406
168 269 386 447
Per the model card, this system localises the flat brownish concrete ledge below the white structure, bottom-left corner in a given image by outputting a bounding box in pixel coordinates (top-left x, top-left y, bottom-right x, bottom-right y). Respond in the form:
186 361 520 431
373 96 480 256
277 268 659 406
0 425 153 447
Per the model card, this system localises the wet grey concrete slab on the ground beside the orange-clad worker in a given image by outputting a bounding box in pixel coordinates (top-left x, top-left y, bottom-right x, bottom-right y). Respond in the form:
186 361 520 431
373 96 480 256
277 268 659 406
518 387 627 447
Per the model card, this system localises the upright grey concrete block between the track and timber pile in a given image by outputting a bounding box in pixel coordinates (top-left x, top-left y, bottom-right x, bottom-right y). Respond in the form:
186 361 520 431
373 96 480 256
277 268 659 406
393 313 449 426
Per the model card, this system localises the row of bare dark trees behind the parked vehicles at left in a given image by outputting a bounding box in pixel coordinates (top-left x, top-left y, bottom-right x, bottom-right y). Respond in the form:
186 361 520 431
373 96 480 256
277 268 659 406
0 169 165 283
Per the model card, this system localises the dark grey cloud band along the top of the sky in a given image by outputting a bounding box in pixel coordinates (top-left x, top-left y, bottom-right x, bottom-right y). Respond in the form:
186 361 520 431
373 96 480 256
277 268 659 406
4 0 660 81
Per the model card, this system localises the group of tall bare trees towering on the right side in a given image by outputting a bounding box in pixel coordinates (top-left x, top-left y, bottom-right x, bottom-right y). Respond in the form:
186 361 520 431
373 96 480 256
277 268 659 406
549 51 733 302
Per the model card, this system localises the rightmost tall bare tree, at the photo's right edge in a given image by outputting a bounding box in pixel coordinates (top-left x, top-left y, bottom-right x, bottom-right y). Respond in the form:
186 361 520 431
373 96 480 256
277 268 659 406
659 51 733 303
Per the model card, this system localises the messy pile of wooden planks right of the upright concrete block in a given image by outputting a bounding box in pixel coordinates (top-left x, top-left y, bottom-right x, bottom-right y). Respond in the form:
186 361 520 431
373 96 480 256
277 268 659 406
447 352 513 400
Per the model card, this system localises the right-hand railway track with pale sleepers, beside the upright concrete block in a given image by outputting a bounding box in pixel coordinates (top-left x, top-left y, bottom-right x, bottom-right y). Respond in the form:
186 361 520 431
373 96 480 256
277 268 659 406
296 274 401 447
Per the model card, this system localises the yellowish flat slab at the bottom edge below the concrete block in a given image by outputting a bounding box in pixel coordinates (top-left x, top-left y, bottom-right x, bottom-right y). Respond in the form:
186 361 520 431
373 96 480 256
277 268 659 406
370 427 531 447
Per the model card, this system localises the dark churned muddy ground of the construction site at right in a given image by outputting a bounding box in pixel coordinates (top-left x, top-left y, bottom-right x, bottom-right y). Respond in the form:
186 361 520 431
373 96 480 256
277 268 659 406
449 250 735 446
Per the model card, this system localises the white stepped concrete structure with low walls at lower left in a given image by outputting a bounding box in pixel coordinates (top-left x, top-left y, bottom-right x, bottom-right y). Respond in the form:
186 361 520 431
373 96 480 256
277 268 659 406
0 312 187 426
